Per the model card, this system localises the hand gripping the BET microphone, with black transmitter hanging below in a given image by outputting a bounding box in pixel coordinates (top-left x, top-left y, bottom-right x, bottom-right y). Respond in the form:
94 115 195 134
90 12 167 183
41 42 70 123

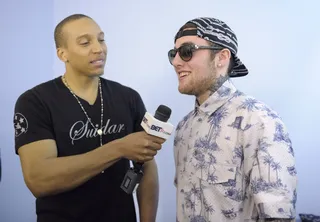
121 105 174 194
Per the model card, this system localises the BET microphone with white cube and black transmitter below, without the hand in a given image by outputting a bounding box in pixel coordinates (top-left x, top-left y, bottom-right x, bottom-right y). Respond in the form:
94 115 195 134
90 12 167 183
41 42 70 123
120 105 174 194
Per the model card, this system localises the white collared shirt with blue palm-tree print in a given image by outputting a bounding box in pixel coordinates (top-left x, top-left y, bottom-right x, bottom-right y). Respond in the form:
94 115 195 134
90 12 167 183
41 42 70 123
174 80 297 222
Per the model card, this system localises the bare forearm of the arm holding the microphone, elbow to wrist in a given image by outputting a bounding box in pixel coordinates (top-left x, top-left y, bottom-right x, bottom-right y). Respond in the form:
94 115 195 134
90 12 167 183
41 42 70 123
28 140 121 197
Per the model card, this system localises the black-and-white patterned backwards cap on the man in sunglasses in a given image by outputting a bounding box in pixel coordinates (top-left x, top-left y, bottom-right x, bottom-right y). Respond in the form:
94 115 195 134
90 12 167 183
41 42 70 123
174 17 249 77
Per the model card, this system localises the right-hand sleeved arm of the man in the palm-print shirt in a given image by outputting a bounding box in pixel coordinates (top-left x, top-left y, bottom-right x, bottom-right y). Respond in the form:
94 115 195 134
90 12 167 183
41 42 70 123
245 113 297 221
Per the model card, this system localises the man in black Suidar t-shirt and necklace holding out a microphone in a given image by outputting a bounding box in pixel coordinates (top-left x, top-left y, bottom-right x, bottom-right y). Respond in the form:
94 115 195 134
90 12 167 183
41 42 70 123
14 14 164 222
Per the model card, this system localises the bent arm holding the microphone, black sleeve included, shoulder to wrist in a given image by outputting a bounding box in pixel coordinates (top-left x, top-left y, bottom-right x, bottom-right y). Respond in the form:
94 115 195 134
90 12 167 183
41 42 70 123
13 91 121 197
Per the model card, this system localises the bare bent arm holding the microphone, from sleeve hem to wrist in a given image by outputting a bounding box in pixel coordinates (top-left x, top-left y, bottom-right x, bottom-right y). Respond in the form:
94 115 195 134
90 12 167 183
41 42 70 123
18 140 121 197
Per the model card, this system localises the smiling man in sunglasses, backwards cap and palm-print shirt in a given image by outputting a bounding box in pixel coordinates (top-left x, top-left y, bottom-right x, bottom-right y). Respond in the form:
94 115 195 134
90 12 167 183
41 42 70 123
168 18 297 222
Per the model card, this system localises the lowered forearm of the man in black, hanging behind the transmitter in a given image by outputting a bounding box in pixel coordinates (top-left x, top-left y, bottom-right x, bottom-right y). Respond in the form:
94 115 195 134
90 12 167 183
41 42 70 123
137 160 159 222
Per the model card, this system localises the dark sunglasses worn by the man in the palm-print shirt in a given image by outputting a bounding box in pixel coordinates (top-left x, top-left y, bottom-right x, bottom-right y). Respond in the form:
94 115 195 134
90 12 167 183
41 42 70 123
168 44 223 65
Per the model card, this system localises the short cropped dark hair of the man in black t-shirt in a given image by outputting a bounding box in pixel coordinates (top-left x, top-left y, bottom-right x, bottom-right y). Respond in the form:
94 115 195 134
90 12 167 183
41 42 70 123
54 14 92 48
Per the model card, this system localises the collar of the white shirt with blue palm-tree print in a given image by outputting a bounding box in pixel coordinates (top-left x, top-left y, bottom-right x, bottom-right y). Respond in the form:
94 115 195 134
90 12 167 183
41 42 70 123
195 79 237 115
